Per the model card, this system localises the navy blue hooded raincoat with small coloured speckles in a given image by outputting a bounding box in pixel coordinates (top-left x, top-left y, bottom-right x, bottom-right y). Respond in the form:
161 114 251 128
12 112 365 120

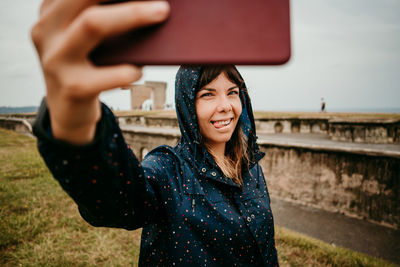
34 67 278 266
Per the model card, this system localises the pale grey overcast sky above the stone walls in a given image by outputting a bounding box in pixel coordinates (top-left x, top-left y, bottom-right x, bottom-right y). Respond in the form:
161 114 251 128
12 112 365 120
0 0 400 112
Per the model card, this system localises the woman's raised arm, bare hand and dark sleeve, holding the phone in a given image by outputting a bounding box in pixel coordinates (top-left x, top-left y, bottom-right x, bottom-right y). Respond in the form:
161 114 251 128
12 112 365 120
32 0 168 229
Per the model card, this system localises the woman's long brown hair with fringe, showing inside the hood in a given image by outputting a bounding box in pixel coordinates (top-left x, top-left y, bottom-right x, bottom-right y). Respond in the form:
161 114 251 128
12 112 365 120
197 65 250 186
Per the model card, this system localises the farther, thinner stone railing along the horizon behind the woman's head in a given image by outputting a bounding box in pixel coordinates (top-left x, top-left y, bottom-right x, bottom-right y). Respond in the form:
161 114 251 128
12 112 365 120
118 116 400 144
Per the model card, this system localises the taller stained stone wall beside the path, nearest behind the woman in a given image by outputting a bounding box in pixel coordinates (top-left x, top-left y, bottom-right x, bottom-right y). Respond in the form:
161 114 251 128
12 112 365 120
121 126 400 228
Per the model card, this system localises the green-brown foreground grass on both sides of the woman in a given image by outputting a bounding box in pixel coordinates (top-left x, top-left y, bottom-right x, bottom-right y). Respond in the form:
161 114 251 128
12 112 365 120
0 129 395 266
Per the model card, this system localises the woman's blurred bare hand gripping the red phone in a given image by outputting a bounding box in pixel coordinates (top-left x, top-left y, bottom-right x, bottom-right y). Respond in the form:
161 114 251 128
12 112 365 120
31 0 169 144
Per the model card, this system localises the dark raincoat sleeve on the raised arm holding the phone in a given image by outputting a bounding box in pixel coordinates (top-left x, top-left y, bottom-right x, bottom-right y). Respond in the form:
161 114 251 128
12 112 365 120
33 100 165 229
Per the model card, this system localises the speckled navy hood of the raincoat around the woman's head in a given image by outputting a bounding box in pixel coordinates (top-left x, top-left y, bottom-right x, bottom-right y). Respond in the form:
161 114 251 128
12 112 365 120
175 66 264 175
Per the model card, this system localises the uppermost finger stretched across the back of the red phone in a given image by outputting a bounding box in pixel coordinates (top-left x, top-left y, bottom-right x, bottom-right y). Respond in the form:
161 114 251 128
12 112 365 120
64 1 169 56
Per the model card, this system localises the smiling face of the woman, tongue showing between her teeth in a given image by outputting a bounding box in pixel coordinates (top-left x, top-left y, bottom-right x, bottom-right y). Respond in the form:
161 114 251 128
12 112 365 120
196 72 242 150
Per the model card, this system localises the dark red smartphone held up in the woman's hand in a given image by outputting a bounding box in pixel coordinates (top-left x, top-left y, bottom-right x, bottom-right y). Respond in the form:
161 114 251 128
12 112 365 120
90 0 291 65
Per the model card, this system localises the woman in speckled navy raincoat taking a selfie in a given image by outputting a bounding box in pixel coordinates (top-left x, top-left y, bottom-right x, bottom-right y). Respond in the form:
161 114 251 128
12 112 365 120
32 0 278 266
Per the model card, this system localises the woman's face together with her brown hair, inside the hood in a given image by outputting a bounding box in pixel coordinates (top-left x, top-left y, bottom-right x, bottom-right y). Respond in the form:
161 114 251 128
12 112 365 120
195 66 249 184
